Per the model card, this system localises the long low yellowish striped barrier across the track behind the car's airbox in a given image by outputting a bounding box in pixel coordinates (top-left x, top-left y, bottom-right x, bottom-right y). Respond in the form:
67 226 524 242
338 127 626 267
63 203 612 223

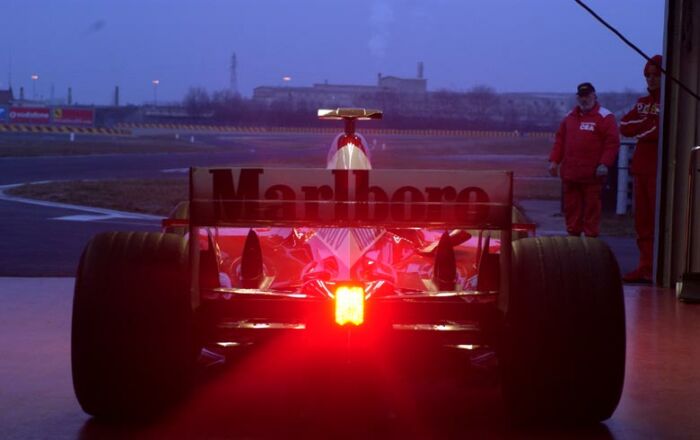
117 123 554 139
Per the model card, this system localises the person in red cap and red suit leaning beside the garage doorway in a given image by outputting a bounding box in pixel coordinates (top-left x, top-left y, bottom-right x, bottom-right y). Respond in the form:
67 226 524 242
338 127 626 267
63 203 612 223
620 55 661 283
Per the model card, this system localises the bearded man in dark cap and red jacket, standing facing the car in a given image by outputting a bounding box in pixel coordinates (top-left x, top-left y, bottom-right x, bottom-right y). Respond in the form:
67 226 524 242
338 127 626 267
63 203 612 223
549 83 620 237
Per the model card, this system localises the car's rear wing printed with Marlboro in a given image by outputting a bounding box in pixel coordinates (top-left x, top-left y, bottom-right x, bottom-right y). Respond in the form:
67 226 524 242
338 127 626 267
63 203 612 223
190 168 513 229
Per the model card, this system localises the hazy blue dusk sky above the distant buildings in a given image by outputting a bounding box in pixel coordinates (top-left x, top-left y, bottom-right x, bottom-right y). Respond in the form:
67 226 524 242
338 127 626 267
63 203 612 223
0 0 665 104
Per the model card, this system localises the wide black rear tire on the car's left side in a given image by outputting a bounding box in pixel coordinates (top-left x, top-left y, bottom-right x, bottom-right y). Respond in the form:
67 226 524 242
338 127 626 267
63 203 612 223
71 232 199 419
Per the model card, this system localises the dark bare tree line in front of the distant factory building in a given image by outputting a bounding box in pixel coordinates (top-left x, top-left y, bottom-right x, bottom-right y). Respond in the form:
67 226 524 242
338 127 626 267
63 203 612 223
171 85 639 131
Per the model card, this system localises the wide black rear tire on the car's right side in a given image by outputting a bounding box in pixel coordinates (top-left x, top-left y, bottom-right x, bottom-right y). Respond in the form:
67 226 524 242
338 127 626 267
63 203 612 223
499 237 625 425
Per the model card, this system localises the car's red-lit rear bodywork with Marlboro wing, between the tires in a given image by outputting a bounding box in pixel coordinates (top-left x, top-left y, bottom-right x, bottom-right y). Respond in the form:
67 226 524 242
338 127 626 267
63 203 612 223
190 168 512 352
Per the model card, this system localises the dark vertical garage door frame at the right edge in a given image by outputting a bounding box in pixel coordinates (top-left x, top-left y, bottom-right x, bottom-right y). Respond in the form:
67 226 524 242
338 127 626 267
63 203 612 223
654 0 700 287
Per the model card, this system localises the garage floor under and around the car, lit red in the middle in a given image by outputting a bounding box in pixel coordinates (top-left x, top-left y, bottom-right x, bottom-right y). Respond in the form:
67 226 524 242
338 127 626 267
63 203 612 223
0 278 700 440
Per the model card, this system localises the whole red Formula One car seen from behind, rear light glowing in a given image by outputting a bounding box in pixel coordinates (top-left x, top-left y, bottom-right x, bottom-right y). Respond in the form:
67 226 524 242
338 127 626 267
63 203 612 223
72 109 625 423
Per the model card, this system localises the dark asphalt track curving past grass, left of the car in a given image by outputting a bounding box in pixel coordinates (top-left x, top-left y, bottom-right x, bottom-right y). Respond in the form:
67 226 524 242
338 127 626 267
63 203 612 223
0 136 316 276
